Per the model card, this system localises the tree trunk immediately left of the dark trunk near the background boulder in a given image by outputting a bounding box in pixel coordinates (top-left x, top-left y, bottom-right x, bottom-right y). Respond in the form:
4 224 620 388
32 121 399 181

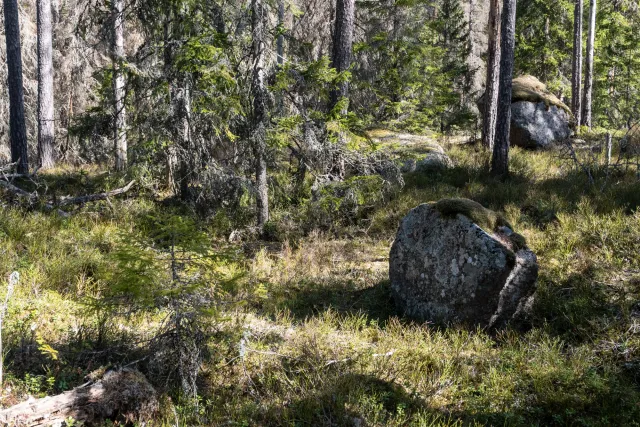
482 0 502 150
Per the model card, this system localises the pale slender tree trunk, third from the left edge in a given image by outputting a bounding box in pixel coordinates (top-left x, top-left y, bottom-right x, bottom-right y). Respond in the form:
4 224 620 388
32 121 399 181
112 0 127 171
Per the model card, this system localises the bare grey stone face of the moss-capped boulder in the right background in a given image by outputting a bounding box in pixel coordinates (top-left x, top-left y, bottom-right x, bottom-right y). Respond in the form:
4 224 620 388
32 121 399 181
509 101 572 148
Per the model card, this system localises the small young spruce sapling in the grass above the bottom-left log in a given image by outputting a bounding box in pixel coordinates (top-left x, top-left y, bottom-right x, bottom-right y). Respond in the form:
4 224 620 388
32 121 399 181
95 214 234 398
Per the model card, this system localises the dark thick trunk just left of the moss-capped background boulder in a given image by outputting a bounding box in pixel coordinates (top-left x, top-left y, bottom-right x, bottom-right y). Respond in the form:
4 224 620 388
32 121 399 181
491 0 516 176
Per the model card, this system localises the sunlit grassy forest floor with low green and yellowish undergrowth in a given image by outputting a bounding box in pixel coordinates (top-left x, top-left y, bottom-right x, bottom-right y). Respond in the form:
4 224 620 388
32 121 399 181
0 132 640 426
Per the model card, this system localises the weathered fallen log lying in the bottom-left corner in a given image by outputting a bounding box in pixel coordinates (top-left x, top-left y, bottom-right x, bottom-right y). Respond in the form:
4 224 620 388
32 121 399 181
0 368 159 427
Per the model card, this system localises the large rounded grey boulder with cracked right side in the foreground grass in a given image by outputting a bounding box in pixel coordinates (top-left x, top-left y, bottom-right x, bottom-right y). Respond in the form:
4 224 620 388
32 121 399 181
389 199 538 329
